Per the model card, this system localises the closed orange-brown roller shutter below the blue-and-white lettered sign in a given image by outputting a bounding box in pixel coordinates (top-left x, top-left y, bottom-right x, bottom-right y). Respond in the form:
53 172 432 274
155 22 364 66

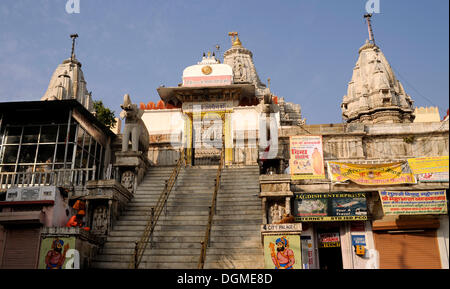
374 230 441 269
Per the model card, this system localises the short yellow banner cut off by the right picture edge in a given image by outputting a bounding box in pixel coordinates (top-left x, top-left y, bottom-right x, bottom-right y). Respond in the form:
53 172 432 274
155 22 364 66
408 156 449 182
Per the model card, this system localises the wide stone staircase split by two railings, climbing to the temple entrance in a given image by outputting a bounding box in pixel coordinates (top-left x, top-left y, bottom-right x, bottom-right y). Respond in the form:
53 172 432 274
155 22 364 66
92 166 263 269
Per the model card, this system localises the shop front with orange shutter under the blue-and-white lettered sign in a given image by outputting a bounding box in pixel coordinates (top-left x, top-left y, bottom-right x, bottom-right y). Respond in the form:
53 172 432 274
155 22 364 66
372 190 448 269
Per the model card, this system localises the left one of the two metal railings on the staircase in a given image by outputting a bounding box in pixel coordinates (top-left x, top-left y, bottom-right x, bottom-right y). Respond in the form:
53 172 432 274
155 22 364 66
128 149 185 269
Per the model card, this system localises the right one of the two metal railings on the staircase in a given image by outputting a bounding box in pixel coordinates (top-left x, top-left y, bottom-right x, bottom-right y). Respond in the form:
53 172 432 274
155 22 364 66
198 142 225 269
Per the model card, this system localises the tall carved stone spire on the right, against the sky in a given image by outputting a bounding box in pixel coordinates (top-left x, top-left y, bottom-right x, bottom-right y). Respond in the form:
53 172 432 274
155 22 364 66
341 18 414 123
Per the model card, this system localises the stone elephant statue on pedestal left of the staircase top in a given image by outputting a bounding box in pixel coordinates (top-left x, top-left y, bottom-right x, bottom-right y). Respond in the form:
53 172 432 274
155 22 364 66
120 94 149 152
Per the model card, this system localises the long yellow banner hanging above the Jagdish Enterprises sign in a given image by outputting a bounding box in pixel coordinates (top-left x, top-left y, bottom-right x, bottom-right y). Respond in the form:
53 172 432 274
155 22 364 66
328 162 416 186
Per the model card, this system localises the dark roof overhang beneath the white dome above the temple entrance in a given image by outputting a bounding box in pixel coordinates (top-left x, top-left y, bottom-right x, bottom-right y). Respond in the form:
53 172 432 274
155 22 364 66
157 84 257 105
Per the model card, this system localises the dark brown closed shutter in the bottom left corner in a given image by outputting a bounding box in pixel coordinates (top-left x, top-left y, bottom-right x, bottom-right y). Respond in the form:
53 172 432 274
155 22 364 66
1 226 40 269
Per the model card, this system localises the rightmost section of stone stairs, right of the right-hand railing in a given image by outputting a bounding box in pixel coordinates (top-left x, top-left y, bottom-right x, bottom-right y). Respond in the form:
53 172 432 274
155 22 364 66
204 166 264 269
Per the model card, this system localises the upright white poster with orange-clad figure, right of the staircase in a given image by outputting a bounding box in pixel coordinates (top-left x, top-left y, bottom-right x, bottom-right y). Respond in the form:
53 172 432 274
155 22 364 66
289 135 325 180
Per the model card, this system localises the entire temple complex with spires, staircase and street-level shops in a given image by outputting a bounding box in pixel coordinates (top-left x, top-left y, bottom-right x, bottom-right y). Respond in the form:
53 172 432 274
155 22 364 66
0 15 449 270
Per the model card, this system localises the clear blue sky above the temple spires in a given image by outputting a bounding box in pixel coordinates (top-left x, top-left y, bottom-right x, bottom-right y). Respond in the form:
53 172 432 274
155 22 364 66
0 0 449 124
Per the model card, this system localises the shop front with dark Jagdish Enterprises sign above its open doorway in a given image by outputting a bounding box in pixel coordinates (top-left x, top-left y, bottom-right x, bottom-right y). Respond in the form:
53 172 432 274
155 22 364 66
293 193 371 270
